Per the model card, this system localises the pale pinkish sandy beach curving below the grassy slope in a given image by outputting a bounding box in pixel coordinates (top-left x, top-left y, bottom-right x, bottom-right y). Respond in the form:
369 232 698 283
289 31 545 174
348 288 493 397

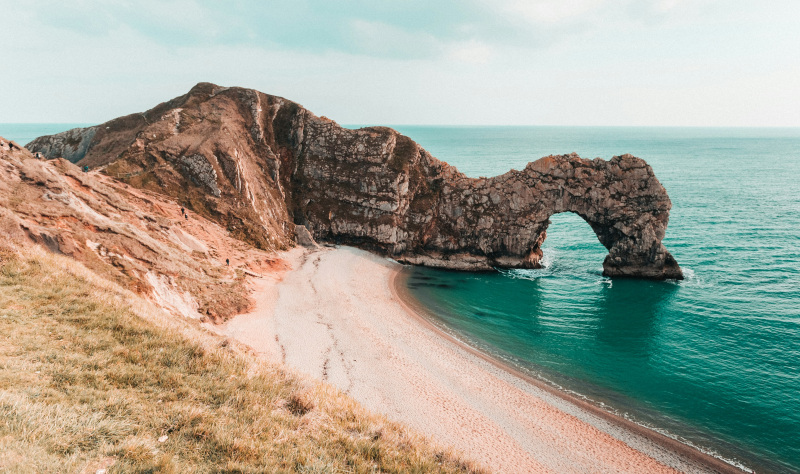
218 247 735 473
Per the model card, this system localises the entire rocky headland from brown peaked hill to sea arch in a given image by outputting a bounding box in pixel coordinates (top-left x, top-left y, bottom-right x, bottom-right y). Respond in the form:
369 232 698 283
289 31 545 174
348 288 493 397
28 83 682 279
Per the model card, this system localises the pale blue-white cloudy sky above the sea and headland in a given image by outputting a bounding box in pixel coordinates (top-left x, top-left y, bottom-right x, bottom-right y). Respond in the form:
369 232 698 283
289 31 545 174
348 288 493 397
0 0 800 127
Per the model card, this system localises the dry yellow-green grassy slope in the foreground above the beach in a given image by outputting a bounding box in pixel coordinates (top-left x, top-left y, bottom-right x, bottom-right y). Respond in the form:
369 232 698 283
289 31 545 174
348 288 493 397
0 245 482 473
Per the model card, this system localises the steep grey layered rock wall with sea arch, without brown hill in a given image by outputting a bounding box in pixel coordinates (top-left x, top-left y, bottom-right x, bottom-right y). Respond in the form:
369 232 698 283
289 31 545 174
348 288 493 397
282 115 682 279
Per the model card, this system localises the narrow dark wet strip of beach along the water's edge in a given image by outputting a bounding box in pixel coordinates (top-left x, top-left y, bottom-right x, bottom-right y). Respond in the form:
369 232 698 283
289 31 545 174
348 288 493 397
390 267 748 474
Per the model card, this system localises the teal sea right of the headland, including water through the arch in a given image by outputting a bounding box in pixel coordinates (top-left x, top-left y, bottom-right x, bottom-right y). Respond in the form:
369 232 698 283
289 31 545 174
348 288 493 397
396 126 800 472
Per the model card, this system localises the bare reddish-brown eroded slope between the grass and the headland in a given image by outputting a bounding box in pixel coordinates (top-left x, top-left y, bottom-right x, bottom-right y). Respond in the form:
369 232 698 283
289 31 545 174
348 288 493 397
0 138 282 321
